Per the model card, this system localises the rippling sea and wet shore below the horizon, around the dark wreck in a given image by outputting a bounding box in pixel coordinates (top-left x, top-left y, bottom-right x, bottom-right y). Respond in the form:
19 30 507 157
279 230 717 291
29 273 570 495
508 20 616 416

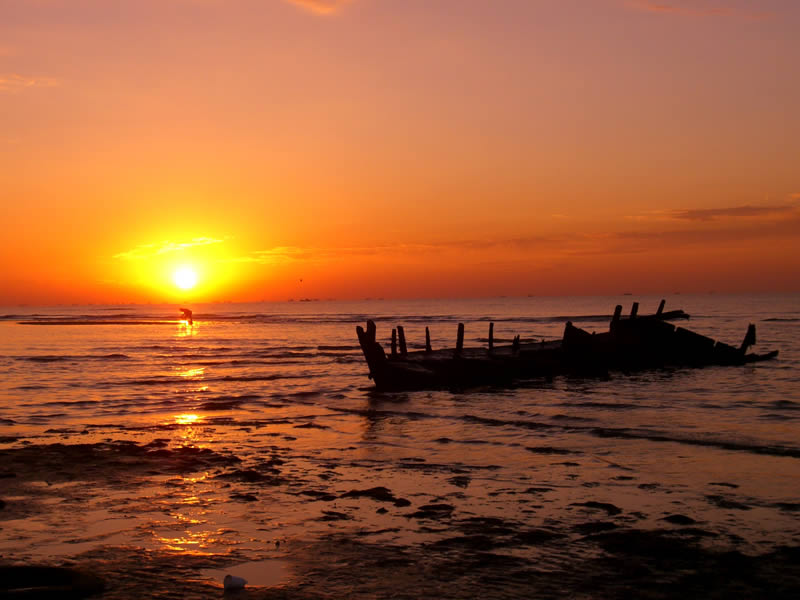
0 294 800 598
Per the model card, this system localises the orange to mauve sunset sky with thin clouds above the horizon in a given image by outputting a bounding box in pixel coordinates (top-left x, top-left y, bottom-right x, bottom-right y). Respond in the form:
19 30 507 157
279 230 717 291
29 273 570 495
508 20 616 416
0 0 800 304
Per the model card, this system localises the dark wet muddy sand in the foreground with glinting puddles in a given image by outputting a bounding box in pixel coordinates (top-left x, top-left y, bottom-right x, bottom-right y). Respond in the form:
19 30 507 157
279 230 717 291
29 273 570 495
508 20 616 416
0 419 800 599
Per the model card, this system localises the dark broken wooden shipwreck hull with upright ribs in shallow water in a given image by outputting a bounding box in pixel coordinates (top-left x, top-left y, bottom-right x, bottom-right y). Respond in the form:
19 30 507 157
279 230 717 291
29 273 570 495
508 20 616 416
356 300 778 390
